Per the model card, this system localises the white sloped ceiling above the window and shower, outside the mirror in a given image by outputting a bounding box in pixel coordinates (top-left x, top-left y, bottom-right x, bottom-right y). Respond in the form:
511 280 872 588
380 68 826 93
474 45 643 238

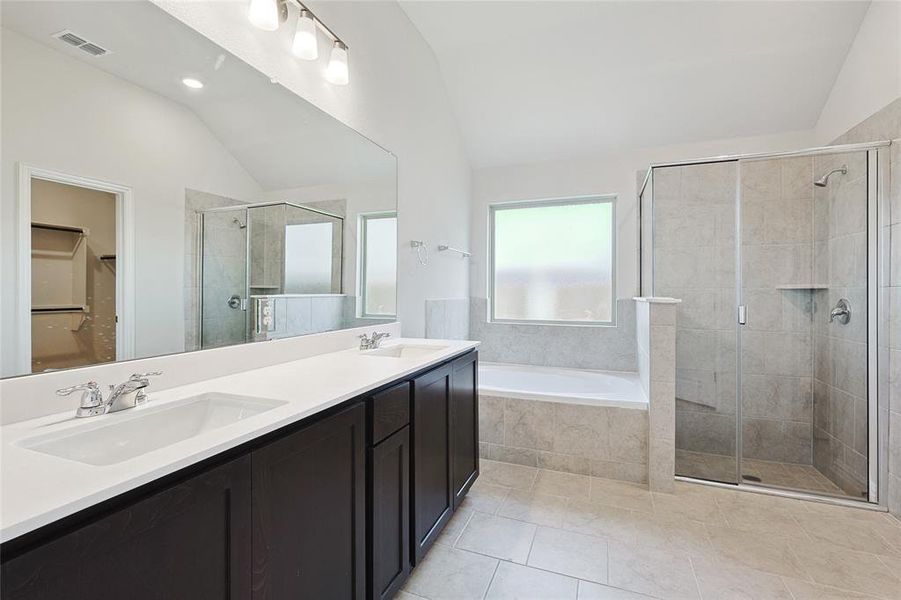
401 0 868 167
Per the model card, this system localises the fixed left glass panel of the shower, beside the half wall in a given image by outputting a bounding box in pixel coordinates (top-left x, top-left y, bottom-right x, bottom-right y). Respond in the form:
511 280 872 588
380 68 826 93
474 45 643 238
650 161 739 483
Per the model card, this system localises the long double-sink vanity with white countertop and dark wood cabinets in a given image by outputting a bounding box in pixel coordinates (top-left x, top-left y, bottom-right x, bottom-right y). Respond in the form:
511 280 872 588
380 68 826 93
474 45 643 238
0 342 478 600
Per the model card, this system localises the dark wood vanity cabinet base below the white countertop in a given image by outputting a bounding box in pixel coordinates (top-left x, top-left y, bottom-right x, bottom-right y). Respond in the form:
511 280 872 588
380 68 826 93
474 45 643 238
0 351 478 600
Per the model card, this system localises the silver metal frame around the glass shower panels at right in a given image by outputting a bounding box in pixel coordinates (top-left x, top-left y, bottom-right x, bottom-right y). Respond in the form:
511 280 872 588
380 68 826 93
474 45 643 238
637 140 891 508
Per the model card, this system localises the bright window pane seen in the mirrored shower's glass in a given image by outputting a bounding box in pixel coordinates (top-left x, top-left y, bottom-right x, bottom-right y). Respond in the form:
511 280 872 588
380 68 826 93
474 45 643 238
285 222 333 294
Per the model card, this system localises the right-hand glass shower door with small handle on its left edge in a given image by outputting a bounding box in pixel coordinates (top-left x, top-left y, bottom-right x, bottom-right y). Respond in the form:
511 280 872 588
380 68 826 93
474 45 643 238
738 151 869 499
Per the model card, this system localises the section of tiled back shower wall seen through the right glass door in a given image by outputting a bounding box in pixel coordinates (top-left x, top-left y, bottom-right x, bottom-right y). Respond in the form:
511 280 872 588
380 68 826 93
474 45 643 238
731 157 814 465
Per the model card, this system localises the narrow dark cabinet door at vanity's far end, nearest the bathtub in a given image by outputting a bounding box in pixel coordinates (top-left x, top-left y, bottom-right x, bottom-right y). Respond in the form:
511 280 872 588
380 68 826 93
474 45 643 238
451 352 479 510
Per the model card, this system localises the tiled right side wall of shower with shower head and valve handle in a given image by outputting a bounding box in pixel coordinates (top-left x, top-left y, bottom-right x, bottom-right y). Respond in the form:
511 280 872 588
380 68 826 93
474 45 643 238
813 152 868 497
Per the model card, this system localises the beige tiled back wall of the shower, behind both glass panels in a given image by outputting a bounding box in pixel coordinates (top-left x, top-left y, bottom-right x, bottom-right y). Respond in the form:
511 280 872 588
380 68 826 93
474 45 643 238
654 158 813 464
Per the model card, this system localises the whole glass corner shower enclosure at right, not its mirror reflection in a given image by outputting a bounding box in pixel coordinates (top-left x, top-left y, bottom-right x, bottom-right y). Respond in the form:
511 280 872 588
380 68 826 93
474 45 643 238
639 143 889 502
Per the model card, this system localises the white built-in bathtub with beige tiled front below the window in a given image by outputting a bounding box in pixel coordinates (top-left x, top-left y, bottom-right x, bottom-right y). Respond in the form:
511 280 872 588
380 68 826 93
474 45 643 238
479 363 648 483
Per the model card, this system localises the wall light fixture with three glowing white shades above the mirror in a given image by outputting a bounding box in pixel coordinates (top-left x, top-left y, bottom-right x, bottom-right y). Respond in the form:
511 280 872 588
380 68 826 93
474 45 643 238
247 0 350 85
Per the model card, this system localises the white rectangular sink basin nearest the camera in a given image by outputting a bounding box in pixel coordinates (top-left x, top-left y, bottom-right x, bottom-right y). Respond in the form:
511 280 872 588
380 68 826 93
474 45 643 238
18 392 287 466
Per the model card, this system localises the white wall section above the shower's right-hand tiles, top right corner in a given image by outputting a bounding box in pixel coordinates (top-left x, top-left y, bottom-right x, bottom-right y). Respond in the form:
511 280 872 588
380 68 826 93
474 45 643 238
816 0 901 145
